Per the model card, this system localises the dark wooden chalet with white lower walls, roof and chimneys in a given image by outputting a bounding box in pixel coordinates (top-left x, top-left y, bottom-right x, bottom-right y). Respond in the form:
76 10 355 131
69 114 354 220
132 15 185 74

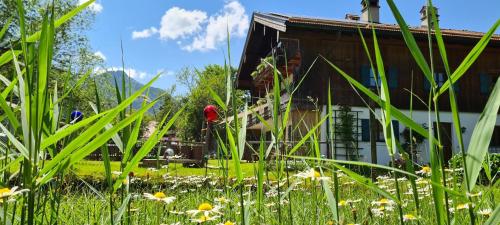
237 1 500 164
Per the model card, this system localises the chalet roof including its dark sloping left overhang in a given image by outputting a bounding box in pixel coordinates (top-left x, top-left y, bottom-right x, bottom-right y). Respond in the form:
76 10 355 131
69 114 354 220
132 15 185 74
238 12 500 89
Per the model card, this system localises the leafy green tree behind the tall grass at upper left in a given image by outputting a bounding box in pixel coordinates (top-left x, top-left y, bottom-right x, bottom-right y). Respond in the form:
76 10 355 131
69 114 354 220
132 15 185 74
0 0 103 118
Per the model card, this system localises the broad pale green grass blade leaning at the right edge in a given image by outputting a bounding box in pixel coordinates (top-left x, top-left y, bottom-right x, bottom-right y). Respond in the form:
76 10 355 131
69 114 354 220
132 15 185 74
466 79 500 190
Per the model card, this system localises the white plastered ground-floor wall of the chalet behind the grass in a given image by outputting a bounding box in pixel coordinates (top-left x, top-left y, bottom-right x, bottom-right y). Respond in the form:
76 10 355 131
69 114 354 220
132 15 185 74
321 106 500 165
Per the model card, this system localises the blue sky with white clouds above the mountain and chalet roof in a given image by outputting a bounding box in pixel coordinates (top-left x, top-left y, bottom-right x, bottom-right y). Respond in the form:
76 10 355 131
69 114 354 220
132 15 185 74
87 0 500 94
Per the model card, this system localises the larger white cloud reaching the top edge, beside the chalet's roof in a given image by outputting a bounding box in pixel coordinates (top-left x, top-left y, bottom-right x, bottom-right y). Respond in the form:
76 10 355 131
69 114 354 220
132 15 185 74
183 1 249 52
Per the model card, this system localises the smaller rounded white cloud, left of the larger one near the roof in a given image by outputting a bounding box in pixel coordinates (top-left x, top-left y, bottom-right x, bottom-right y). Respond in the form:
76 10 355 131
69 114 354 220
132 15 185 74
159 7 207 40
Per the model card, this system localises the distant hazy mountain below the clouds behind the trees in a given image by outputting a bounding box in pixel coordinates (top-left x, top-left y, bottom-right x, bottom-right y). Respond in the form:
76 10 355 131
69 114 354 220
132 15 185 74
99 70 165 113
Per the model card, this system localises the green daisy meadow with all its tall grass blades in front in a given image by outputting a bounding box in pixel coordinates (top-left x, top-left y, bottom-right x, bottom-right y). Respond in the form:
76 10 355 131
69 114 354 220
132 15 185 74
0 0 500 225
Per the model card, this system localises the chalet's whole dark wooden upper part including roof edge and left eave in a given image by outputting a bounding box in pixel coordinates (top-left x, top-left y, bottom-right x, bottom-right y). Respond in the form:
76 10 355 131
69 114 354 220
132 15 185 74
238 14 500 112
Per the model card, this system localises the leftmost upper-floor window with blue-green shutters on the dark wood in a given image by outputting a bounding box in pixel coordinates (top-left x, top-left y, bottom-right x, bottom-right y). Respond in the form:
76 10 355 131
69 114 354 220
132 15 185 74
361 65 398 89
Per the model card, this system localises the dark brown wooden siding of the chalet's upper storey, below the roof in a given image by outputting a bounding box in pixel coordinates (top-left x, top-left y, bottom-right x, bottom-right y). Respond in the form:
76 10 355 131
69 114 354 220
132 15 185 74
280 29 500 112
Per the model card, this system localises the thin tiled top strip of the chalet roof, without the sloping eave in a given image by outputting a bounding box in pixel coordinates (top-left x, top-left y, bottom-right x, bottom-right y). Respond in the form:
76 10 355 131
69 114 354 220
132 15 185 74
254 12 500 41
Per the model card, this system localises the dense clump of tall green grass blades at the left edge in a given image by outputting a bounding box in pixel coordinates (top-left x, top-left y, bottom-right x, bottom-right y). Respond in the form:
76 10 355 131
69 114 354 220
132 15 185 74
0 0 182 224
